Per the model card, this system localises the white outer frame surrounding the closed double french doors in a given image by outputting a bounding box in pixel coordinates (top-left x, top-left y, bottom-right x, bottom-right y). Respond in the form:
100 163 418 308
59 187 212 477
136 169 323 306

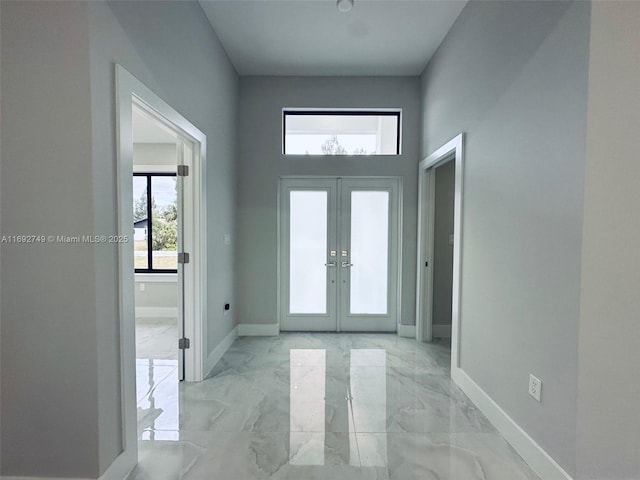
276 175 403 333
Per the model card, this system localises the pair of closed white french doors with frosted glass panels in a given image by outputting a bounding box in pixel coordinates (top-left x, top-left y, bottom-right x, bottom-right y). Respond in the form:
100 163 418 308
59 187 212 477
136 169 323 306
280 177 400 332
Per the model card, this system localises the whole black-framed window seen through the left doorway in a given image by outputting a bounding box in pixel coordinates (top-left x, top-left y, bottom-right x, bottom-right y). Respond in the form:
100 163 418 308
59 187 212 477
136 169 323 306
133 173 178 273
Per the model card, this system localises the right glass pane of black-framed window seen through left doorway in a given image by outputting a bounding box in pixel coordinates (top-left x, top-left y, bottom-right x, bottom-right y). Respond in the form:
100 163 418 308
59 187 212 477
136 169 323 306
151 176 178 270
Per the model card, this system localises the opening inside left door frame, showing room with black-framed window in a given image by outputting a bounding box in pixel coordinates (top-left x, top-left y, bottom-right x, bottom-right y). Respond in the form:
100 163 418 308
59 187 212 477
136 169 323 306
132 105 184 382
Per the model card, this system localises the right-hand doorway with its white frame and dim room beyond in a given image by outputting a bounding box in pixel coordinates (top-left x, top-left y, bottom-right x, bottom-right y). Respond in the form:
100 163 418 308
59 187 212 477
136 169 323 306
416 134 463 368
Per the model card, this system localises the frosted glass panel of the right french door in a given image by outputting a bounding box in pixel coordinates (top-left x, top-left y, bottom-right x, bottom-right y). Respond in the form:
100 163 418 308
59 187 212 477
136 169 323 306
349 191 389 314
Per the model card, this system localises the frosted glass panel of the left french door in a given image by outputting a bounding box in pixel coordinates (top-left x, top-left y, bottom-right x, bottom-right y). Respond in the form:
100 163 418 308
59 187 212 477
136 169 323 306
289 190 327 314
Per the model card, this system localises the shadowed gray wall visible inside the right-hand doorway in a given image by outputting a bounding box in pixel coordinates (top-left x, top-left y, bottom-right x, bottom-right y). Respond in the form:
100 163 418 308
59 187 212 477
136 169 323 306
433 161 456 325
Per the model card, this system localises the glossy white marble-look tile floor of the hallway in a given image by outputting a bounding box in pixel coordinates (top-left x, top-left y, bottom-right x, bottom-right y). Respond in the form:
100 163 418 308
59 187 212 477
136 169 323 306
130 334 538 480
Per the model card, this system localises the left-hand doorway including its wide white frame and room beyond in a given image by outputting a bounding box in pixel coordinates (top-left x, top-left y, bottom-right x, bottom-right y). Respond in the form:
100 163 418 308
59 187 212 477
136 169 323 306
116 65 207 464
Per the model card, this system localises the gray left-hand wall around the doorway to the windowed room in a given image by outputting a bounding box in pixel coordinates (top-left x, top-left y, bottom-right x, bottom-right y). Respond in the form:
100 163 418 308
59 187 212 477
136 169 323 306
1 2 238 478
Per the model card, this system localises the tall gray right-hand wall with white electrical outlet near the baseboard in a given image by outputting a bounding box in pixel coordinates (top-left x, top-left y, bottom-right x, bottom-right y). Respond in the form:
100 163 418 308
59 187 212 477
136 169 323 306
422 1 590 474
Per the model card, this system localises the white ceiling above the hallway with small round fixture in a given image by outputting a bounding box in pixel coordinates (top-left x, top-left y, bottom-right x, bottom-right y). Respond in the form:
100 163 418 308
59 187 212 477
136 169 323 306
200 0 467 76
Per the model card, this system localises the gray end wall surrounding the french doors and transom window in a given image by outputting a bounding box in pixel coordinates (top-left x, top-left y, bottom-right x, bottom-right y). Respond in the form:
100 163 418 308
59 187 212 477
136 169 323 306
237 77 420 324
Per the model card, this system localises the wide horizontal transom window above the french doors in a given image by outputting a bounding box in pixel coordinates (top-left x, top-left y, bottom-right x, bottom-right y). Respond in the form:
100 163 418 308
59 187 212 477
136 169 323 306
282 109 401 155
